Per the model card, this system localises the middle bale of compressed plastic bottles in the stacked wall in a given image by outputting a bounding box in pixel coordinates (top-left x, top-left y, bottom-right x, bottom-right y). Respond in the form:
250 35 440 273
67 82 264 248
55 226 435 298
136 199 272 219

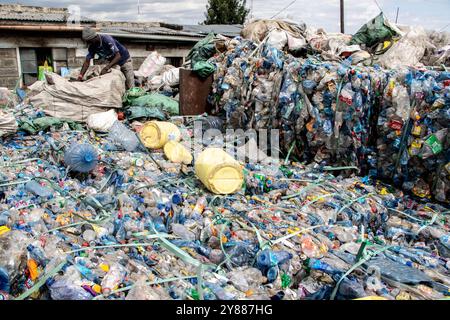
290 58 385 172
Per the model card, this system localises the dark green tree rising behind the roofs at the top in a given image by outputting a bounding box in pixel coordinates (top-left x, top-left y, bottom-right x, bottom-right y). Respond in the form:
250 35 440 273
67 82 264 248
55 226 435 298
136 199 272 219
203 0 250 24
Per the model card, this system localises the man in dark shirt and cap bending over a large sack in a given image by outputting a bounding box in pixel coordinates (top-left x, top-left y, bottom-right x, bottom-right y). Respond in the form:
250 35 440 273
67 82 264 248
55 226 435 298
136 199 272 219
78 27 134 89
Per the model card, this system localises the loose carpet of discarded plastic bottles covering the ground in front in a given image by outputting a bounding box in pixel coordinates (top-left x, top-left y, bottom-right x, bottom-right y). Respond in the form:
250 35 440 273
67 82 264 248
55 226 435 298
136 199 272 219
0 105 450 300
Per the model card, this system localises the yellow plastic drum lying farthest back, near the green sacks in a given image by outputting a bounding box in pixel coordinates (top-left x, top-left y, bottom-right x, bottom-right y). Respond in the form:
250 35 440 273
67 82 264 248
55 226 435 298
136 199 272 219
139 121 181 149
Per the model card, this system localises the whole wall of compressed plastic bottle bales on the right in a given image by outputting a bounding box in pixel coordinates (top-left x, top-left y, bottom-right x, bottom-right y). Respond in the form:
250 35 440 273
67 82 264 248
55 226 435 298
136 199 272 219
209 37 450 202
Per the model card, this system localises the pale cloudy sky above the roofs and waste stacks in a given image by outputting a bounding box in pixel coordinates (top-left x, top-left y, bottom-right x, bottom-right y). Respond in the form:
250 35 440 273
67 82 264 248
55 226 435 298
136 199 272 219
0 0 450 33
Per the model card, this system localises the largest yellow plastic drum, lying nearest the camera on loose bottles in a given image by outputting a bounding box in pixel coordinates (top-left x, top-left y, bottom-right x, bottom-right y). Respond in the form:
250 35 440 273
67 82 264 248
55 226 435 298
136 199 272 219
195 148 244 194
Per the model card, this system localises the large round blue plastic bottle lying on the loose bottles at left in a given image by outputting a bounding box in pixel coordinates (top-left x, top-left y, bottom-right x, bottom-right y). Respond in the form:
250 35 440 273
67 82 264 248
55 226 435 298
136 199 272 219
64 143 98 172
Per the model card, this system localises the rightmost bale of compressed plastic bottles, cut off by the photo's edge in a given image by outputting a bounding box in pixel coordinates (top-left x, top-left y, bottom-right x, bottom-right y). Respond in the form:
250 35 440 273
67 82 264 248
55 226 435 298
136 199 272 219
377 69 450 201
